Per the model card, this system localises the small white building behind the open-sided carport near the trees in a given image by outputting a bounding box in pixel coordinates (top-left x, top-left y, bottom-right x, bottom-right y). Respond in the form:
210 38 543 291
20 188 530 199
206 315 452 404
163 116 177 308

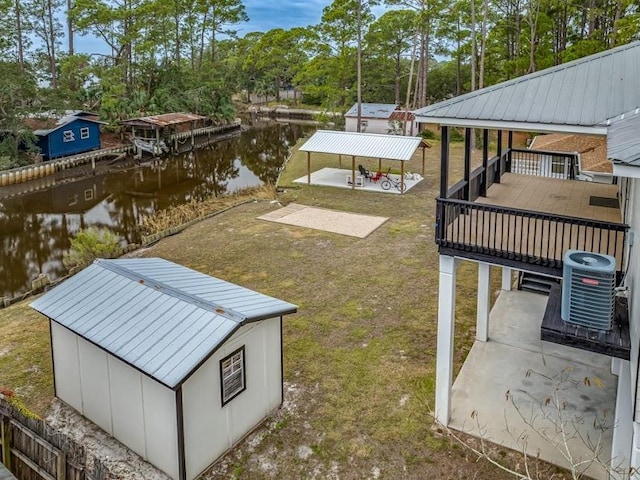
344 103 418 135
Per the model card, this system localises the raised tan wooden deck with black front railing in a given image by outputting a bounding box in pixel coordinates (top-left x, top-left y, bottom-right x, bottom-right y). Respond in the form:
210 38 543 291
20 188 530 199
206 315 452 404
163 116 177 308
438 174 626 275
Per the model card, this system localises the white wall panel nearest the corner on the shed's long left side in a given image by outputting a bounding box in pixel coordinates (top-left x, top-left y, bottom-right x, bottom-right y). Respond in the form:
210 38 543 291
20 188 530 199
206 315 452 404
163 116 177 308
142 376 178 479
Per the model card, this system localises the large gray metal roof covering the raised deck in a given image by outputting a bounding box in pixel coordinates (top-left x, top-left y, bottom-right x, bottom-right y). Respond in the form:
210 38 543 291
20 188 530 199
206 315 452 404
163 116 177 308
414 42 640 135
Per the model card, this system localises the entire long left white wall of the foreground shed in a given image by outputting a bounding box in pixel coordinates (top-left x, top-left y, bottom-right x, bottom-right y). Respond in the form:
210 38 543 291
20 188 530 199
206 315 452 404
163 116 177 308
51 322 178 479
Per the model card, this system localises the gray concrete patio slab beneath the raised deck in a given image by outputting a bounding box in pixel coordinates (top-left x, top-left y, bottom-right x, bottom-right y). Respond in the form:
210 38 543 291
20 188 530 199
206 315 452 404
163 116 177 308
449 290 617 479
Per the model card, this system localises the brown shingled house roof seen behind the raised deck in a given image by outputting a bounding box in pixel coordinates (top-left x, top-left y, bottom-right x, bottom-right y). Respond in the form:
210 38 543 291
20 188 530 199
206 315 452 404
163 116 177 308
530 133 613 173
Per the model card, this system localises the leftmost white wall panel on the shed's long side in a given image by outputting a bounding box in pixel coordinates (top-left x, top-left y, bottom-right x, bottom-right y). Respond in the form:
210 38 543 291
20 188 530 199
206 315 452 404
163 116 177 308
51 322 83 413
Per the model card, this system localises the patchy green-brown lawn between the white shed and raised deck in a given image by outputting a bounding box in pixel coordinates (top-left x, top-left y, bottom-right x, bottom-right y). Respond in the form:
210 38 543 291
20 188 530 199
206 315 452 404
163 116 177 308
0 133 556 480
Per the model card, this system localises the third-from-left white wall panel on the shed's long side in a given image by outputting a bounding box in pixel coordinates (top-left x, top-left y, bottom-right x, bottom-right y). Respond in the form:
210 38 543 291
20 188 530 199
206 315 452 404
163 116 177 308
108 355 147 458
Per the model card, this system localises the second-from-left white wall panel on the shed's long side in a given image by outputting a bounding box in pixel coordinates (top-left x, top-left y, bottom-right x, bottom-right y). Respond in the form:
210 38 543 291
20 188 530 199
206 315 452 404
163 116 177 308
78 337 113 435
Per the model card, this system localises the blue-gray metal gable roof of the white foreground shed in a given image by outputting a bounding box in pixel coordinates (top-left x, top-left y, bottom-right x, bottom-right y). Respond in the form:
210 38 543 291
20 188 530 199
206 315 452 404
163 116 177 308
31 258 297 388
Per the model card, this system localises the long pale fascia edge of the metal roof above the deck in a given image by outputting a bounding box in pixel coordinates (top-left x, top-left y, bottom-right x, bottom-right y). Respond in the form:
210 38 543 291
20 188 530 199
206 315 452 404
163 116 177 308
416 115 607 135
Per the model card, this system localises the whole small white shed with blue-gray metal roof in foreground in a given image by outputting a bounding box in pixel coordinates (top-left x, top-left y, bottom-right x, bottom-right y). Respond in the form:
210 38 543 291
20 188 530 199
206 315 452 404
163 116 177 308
31 258 297 480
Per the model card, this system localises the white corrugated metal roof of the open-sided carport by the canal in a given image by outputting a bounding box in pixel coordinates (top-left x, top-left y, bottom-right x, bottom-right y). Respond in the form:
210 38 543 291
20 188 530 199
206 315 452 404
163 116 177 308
300 130 423 161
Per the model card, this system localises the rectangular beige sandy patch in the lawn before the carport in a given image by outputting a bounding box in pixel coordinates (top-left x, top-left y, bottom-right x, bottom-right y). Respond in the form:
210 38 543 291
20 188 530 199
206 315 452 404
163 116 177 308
258 203 389 238
